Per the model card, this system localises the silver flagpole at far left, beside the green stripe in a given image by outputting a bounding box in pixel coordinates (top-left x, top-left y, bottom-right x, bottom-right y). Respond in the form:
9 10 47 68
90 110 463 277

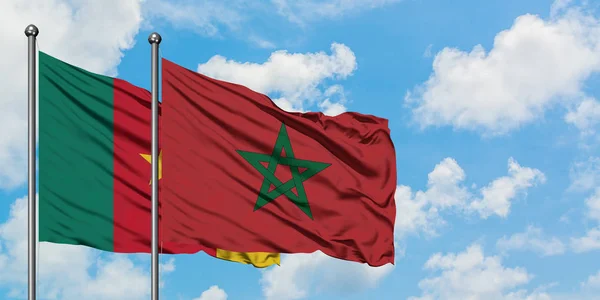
25 24 39 300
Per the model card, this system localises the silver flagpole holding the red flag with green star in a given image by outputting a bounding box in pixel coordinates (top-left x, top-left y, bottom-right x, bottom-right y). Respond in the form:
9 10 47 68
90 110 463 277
148 32 162 300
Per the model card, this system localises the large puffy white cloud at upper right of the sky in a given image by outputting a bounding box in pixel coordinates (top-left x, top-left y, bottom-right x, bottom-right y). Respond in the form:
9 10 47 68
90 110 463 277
405 1 600 135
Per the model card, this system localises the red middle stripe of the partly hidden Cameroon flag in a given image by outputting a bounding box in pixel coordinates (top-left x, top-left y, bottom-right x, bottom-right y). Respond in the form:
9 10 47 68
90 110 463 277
113 79 207 256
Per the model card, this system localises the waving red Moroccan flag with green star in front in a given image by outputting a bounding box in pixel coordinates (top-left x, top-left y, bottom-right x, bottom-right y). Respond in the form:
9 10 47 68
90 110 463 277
160 59 396 266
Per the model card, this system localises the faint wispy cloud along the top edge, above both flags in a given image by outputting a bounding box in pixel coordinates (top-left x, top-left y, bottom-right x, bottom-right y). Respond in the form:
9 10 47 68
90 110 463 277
141 0 400 49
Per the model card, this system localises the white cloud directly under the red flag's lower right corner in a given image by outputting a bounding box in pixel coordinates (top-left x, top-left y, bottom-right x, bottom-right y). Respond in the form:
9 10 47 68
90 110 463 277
261 251 394 300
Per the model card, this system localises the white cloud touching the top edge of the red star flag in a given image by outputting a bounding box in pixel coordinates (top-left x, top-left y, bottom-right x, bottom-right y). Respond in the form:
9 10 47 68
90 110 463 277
198 43 356 112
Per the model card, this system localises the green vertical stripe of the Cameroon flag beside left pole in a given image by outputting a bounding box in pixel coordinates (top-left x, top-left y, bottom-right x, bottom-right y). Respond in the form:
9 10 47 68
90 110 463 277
39 52 113 251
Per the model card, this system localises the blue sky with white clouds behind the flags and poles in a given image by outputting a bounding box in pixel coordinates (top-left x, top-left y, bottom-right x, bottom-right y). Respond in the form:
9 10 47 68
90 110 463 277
0 0 600 300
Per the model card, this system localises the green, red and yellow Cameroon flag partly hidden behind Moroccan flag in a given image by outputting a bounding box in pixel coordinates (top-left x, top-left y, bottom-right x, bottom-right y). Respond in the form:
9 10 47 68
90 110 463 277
39 52 279 267
